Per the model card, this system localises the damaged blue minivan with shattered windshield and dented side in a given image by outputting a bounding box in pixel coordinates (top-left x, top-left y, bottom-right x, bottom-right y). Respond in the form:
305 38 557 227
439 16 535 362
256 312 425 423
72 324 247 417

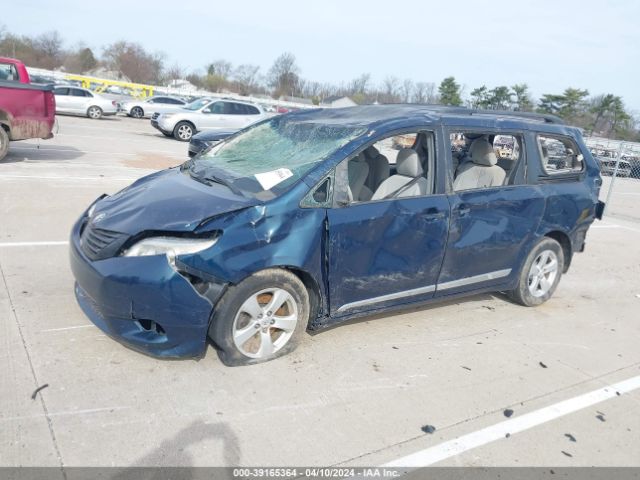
70 105 603 365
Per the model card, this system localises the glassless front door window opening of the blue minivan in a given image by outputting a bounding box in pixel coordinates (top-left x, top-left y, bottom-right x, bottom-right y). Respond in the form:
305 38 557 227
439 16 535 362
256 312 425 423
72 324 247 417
335 131 435 205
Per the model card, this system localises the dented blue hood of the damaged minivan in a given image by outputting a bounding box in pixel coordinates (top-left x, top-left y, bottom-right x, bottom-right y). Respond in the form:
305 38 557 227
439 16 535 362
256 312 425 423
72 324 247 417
91 168 261 235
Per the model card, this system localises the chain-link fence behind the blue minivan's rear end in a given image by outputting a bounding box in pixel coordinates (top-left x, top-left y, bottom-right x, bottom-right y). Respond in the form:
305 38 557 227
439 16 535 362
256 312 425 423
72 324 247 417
585 137 640 222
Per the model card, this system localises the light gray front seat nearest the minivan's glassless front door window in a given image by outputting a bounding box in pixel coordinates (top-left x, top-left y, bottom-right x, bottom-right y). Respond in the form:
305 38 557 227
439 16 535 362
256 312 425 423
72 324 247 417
371 148 429 200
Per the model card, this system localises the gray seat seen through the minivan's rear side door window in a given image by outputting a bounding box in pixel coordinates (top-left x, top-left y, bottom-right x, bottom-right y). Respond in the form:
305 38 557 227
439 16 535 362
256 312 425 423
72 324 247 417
453 139 505 190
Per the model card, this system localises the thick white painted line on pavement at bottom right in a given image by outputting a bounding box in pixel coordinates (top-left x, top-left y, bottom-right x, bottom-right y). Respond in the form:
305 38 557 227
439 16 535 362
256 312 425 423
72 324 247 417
383 376 640 468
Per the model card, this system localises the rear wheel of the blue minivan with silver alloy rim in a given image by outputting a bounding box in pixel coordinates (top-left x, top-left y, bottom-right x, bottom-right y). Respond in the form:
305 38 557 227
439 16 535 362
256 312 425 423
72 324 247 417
508 237 564 307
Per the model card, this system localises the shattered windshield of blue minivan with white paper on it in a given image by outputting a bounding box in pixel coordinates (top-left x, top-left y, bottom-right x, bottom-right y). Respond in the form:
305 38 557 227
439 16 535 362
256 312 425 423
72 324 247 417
189 116 366 200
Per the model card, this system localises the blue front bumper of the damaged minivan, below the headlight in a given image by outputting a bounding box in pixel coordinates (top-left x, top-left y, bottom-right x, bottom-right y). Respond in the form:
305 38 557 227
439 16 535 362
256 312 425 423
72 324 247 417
70 216 223 358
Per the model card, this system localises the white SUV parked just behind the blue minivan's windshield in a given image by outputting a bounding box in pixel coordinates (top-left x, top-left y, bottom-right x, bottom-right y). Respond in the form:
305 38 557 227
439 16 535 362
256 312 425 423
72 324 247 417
151 99 265 142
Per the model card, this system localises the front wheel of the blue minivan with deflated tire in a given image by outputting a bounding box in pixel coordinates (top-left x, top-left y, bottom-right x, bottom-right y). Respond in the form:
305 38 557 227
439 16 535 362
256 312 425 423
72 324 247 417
209 269 309 366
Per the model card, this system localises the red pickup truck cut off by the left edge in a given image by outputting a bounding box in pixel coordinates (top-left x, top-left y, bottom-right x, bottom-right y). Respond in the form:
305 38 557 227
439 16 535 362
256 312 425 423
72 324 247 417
0 57 56 160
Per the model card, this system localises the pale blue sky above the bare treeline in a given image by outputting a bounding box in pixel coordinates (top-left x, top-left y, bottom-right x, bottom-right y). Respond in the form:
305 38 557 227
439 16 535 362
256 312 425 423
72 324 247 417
5 0 640 113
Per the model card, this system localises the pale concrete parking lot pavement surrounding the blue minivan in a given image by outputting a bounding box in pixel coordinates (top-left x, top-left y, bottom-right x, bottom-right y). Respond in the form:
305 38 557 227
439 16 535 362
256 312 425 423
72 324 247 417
0 116 640 466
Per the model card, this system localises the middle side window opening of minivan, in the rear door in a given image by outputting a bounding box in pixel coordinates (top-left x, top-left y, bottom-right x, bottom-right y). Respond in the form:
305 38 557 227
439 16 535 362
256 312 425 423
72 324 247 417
450 131 523 191
